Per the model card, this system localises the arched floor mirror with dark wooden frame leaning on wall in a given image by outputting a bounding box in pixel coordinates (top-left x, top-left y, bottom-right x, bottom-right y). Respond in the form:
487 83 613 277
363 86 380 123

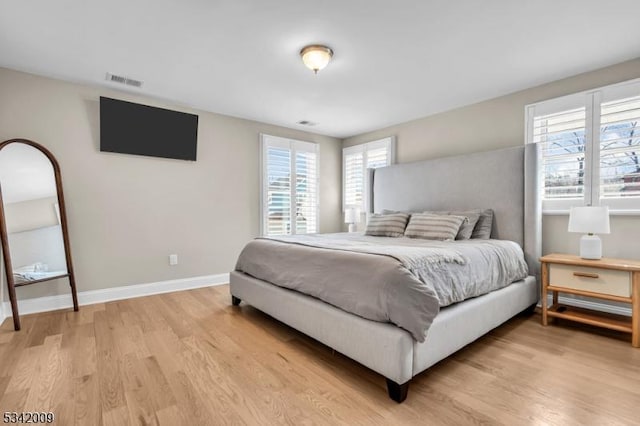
0 139 78 331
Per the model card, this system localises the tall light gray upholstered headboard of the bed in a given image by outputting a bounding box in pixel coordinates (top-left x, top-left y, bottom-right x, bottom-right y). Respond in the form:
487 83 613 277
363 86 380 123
368 144 541 275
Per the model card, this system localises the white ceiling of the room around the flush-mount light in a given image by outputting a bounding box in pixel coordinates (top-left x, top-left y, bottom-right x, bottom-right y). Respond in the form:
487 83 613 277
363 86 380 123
0 0 640 137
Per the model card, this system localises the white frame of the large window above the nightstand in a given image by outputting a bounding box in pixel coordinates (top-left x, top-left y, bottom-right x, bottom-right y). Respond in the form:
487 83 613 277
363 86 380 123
524 78 640 215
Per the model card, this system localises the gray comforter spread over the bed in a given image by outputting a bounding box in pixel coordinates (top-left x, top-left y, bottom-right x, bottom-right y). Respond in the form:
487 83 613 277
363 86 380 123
236 233 528 342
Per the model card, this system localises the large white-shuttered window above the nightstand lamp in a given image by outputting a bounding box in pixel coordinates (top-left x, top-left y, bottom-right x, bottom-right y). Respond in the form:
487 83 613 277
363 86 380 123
525 80 640 212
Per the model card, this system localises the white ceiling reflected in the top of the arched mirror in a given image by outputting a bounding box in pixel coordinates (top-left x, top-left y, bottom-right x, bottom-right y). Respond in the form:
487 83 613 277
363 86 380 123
0 143 58 204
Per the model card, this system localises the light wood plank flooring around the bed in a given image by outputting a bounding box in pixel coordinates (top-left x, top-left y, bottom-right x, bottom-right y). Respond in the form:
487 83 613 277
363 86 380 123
0 286 640 425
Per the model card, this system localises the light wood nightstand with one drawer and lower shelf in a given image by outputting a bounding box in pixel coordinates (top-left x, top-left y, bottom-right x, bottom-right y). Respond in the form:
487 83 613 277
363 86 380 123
540 254 640 348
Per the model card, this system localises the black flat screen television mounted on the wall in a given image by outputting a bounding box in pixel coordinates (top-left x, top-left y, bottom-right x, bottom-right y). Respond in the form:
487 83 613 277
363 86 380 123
100 96 198 161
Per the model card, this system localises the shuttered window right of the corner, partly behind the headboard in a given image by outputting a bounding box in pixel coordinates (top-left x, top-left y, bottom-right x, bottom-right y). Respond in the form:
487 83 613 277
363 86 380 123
342 137 395 211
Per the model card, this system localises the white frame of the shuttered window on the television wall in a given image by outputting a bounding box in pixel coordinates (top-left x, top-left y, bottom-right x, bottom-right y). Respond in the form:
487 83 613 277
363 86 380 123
260 133 320 236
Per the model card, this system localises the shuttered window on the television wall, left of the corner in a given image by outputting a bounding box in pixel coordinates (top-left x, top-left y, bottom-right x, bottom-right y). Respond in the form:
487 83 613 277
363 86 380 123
261 135 319 235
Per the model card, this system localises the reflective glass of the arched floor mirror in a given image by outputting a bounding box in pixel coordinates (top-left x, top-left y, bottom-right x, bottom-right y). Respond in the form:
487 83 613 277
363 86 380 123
0 143 67 286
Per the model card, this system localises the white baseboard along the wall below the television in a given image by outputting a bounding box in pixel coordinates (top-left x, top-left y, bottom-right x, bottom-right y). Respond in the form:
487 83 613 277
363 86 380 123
0 274 229 316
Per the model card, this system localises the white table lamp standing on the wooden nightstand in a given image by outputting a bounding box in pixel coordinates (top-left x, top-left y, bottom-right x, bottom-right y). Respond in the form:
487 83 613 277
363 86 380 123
569 206 611 259
